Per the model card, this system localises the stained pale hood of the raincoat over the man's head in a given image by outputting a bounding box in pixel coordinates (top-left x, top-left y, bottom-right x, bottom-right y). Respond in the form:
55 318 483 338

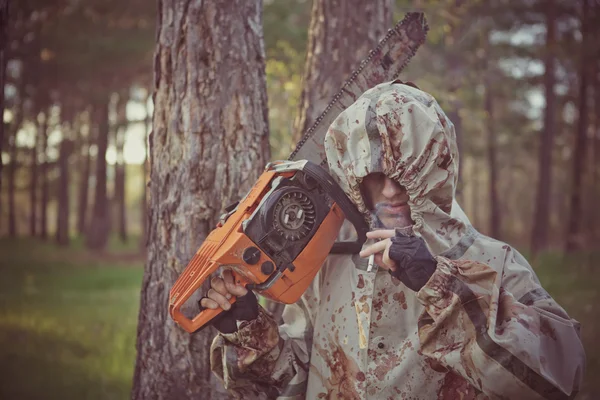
325 81 470 255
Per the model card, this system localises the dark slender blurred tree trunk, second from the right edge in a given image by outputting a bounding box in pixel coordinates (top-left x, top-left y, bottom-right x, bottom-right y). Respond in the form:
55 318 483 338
531 1 556 256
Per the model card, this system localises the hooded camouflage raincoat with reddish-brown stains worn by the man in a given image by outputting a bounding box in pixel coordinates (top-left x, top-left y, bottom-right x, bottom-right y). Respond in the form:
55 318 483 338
211 82 585 399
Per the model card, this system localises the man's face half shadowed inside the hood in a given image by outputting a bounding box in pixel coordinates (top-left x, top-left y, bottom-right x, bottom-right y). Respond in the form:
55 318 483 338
361 172 413 229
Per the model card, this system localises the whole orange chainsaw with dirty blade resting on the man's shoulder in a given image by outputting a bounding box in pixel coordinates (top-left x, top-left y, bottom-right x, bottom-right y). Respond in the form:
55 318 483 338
169 13 428 333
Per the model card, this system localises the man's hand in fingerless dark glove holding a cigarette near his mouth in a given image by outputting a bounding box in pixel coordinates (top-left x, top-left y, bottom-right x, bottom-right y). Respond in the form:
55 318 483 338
360 230 437 292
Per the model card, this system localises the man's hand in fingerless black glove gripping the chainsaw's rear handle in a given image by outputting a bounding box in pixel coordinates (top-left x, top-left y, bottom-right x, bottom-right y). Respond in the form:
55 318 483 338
200 270 258 333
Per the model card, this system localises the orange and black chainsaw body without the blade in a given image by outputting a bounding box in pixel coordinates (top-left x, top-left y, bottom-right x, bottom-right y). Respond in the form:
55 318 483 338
169 161 366 333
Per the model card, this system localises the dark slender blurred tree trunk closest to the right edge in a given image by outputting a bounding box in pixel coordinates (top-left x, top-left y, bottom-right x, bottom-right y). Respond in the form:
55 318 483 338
565 0 590 253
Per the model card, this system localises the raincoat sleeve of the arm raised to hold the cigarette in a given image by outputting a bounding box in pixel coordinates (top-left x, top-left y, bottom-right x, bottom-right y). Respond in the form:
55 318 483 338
418 245 585 399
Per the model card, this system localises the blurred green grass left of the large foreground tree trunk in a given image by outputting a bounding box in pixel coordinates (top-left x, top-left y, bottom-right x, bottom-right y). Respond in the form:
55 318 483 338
0 239 142 399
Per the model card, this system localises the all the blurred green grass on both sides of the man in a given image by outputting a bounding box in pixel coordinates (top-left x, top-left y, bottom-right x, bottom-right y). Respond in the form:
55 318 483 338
0 238 600 399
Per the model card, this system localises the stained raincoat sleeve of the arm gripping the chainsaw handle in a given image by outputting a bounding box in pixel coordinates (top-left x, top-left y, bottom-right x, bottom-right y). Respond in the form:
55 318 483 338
210 268 319 399
